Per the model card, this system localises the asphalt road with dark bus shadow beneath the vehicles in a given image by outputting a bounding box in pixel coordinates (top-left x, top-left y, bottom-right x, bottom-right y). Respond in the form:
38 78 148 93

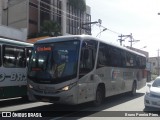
0 87 160 120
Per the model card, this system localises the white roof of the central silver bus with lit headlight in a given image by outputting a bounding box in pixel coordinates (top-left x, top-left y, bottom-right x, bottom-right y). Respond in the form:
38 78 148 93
35 35 146 57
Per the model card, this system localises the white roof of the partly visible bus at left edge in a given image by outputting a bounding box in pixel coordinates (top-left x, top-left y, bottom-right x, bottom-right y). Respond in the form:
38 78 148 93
0 38 33 47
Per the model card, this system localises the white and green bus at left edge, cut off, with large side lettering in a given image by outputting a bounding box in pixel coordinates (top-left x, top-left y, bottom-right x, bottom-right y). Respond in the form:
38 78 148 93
0 38 33 99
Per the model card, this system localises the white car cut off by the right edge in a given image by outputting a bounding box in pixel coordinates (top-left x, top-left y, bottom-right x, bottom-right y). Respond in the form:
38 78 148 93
144 77 160 108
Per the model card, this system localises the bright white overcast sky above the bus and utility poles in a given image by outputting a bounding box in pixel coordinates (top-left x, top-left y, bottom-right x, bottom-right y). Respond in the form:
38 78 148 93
86 0 160 57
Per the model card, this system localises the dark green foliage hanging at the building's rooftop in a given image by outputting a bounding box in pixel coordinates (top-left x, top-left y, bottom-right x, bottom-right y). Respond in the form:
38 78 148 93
69 0 86 11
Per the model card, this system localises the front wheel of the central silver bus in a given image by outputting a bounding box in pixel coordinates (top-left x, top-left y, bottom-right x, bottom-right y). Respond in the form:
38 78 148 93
93 87 104 106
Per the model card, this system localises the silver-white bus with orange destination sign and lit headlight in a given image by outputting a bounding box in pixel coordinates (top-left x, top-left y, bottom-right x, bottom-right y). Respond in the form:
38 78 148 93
27 35 147 105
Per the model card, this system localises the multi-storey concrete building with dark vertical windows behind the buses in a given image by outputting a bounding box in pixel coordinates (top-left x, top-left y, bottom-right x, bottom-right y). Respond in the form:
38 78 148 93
2 0 91 36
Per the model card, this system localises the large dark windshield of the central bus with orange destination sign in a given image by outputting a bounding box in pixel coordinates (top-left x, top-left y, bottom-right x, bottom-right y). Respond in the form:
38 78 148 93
28 40 80 84
